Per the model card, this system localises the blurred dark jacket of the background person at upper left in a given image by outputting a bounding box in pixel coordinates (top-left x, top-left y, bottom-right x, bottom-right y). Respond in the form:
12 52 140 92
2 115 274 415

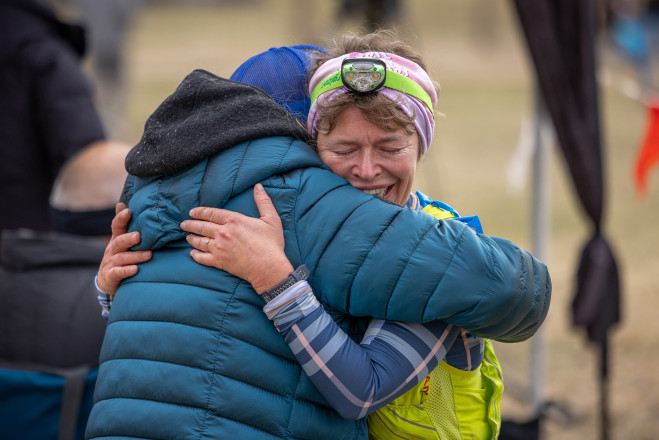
0 0 104 230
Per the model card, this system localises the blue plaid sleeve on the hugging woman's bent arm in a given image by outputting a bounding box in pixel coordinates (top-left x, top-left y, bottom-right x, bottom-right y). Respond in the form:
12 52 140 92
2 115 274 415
271 282 461 419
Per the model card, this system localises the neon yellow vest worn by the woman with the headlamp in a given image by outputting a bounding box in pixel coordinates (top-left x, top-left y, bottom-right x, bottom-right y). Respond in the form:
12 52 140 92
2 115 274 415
368 205 503 440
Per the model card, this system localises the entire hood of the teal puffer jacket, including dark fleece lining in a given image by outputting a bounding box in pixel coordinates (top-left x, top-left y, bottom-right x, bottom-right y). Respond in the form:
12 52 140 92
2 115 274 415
122 70 323 253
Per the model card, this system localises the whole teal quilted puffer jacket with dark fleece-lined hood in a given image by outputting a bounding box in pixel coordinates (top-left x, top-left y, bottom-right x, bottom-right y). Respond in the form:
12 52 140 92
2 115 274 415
87 71 551 440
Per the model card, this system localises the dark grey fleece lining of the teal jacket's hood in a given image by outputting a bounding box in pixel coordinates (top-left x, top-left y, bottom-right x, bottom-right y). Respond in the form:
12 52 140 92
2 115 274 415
126 69 309 177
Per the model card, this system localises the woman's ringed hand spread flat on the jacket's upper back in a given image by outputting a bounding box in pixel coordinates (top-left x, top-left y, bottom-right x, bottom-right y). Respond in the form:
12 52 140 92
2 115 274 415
181 184 293 294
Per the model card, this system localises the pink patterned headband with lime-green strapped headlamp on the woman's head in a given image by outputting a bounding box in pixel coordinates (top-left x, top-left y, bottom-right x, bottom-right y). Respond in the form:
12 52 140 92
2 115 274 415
307 52 437 153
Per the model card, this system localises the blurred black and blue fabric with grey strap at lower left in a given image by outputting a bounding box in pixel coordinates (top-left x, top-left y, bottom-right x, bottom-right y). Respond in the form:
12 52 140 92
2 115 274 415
0 229 106 440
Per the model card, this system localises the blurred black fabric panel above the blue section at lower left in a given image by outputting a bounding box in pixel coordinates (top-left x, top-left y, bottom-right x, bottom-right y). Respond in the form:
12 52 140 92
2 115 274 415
0 230 106 368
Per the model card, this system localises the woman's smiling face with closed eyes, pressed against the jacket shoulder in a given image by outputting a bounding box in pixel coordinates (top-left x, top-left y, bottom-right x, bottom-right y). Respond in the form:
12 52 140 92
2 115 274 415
317 107 419 206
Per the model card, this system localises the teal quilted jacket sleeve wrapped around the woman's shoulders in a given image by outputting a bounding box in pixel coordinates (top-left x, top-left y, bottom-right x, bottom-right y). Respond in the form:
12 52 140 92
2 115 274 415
295 170 551 342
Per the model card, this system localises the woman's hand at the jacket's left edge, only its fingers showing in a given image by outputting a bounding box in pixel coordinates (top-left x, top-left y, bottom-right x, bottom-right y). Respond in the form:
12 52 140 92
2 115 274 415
97 203 151 296
